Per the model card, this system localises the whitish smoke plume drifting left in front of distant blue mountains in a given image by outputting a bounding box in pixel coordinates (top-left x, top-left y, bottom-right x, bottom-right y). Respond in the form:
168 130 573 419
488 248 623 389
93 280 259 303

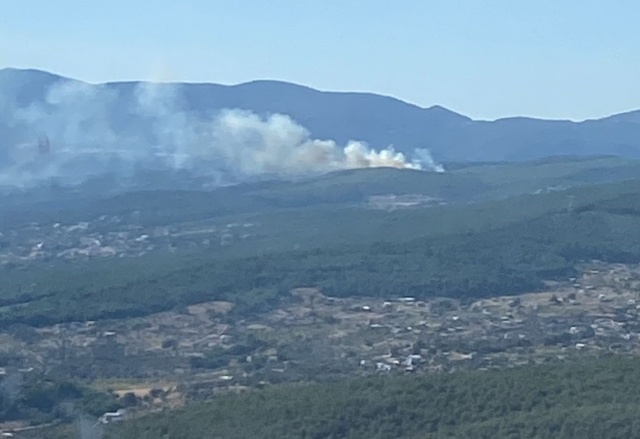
0 81 444 187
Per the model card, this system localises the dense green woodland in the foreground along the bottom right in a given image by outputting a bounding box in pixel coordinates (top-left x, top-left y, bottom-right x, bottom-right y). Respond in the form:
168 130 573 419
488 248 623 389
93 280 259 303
111 357 640 439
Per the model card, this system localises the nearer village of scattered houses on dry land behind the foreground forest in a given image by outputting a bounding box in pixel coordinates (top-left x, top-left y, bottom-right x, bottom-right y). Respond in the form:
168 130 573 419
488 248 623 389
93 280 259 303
0 262 640 432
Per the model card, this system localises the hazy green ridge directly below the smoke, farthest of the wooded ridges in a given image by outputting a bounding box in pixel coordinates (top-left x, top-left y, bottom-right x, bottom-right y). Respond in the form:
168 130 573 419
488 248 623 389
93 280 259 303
0 157 640 227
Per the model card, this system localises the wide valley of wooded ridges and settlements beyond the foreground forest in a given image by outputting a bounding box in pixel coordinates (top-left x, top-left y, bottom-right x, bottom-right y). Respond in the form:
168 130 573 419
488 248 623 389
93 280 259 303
0 158 640 438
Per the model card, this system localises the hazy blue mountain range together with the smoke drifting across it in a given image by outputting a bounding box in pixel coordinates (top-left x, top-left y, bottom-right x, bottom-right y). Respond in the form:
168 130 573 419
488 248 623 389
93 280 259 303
0 69 640 191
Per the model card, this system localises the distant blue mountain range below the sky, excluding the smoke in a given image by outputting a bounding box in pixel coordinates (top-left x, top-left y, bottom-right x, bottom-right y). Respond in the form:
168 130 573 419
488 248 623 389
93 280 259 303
0 69 640 161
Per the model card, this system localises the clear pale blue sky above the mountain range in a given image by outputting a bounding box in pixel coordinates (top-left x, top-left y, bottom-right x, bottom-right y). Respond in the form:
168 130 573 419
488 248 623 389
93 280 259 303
0 0 640 120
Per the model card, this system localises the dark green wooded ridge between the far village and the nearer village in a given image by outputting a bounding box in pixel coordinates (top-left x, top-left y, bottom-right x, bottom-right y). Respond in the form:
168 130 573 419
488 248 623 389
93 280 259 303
0 179 640 326
